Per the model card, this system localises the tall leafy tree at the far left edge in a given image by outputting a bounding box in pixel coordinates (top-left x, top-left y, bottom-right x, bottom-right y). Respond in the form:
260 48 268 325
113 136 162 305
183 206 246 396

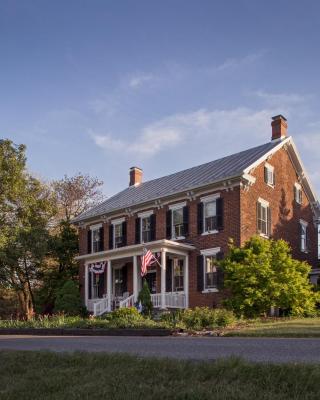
0 140 55 318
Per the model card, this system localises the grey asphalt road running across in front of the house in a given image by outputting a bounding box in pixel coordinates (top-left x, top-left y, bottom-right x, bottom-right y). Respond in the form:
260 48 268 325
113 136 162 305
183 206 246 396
0 335 320 363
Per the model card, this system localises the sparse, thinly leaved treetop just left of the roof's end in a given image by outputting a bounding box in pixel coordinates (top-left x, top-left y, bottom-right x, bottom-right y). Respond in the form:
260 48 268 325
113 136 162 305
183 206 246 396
52 173 104 222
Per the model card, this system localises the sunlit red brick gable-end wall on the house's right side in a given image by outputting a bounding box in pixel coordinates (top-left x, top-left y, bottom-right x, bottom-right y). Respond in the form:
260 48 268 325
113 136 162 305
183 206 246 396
240 148 317 266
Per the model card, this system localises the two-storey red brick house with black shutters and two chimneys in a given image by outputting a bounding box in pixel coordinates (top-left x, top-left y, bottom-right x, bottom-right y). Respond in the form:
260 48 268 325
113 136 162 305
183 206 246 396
73 115 320 315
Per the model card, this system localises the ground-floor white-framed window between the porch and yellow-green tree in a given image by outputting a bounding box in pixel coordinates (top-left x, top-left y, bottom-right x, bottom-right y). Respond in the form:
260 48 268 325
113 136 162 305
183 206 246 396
201 247 220 292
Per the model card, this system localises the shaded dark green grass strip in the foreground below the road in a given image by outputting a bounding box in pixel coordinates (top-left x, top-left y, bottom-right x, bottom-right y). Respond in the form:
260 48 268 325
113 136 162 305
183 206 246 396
0 352 320 400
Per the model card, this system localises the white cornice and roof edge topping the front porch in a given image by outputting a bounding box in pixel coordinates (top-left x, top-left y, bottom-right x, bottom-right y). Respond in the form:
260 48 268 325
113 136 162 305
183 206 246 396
76 239 195 261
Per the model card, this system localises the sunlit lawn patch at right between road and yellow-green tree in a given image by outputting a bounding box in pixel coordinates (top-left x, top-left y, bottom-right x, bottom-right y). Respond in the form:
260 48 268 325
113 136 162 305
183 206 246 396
225 318 320 338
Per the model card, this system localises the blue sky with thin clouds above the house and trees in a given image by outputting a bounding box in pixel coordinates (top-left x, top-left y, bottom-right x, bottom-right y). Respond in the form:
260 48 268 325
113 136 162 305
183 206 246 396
0 0 320 195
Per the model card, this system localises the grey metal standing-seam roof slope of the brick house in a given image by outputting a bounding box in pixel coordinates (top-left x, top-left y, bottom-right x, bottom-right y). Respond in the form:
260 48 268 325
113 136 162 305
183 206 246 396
73 141 279 222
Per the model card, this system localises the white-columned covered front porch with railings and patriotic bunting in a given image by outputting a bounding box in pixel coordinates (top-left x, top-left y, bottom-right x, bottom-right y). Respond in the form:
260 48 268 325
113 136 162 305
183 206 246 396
78 239 194 315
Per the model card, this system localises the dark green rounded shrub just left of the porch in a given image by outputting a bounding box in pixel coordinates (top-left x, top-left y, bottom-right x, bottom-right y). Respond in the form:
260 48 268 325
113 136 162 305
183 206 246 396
54 281 83 315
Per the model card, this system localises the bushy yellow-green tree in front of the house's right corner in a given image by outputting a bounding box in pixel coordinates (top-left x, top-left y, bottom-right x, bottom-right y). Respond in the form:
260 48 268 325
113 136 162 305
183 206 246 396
222 236 317 317
